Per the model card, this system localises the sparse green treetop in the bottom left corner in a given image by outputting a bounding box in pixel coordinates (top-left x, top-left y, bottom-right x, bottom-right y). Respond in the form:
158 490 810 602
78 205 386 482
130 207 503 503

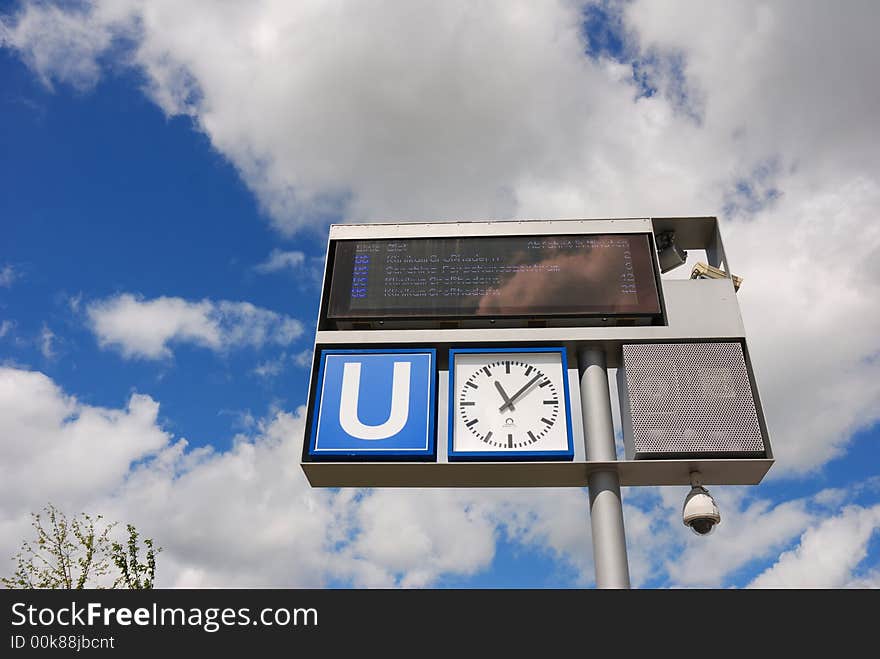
0 503 162 589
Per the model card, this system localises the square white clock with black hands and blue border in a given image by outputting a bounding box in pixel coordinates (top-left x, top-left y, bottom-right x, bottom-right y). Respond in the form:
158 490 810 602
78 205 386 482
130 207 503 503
449 348 574 461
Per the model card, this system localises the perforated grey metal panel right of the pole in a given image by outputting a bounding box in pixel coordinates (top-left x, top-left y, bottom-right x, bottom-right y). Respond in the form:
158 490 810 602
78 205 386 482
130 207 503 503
619 343 765 459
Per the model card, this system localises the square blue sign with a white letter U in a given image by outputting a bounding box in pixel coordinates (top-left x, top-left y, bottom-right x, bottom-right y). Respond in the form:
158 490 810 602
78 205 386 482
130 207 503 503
309 348 437 460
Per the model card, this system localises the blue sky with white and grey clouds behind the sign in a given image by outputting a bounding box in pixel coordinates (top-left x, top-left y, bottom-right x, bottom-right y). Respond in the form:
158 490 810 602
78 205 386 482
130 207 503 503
0 0 880 588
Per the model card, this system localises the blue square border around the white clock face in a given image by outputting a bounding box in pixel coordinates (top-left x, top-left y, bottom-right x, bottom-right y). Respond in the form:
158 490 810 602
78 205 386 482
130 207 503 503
446 346 574 462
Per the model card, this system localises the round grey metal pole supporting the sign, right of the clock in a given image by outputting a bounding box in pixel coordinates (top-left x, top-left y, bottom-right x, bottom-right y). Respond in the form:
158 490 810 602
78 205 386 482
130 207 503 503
578 348 629 588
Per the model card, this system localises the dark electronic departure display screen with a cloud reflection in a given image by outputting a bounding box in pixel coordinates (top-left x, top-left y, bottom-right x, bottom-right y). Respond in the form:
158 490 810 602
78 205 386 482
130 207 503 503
327 234 660 319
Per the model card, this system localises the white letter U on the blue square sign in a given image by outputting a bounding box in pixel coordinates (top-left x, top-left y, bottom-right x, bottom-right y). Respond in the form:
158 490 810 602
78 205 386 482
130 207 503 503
339 362 410 439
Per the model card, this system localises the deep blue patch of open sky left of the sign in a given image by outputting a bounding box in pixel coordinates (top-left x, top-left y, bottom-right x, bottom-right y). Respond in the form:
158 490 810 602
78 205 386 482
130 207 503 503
2 45 324 445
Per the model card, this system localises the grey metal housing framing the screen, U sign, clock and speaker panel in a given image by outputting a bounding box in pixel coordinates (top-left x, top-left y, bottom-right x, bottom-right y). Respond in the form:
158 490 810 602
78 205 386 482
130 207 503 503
301 217 773 487
